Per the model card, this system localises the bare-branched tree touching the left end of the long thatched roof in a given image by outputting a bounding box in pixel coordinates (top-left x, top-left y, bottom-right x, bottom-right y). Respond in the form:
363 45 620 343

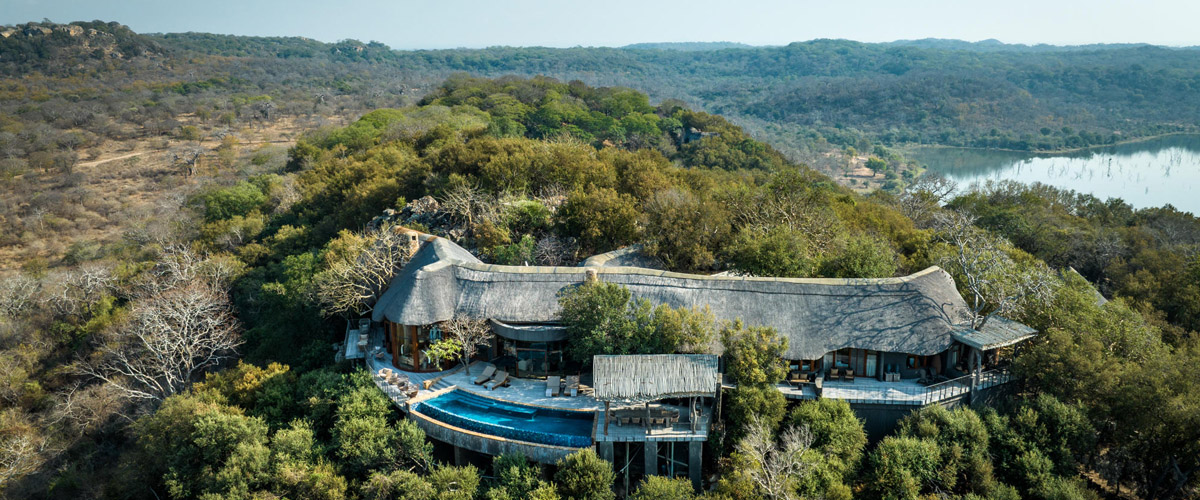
317 225 413 315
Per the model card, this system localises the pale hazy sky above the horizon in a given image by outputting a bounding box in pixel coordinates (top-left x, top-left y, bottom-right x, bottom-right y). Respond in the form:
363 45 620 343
0 0 1200 49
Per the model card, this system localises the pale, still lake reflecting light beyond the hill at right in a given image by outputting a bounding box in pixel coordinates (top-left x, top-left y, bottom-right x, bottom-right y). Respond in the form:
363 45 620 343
908 135 1200 213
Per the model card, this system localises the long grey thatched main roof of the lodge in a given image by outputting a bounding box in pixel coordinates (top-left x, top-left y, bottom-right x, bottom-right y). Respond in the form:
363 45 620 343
373 237 993 360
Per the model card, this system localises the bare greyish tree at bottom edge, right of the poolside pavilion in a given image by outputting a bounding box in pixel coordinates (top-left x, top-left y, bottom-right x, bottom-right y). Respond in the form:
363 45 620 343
737 415 812 500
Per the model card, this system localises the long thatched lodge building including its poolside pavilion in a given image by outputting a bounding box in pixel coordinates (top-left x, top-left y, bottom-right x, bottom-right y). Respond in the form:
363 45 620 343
357 233 1034 481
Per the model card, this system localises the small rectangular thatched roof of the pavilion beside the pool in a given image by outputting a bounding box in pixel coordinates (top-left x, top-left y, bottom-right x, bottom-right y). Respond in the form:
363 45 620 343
592 354 720 403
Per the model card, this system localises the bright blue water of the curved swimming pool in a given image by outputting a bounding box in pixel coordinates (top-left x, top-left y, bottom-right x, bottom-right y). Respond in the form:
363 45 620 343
413 390 594 447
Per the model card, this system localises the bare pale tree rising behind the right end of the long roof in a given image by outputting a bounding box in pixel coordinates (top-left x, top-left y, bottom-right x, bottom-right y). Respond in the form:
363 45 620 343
934 210 1055 330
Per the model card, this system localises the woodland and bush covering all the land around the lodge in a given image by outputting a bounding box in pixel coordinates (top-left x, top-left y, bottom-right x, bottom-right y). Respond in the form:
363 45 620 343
0 23 1200 499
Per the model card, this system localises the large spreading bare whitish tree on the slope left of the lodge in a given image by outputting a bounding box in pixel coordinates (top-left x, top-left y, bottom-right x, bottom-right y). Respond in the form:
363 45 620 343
77 281 241 402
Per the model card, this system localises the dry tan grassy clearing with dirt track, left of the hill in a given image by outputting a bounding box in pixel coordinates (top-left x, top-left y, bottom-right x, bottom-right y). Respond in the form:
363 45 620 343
0 118 331 272
